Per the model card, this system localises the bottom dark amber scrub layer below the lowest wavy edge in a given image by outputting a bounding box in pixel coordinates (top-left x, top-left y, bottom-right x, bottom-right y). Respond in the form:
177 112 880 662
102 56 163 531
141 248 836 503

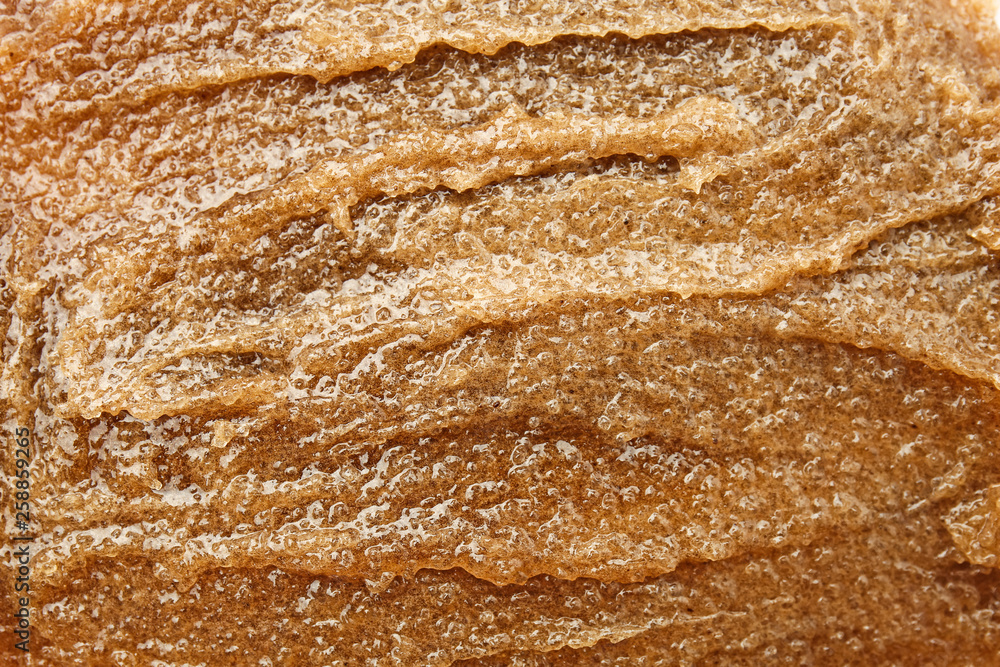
31 514 1000 665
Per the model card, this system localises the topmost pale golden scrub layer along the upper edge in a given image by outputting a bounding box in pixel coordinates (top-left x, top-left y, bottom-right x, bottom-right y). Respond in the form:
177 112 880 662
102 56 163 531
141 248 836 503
0 0 853 121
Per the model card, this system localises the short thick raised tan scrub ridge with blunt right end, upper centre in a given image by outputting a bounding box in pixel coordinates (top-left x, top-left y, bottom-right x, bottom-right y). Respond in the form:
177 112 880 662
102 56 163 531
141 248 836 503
207 97 759 261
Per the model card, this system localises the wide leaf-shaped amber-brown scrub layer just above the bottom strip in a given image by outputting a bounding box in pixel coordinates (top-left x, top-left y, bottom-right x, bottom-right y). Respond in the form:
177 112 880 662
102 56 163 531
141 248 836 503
29 326 998 584
